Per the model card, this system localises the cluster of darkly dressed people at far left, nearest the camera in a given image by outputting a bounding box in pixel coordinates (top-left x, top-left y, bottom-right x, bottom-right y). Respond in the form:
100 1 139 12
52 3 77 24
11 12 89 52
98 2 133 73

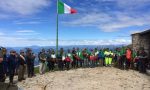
0 47 35 84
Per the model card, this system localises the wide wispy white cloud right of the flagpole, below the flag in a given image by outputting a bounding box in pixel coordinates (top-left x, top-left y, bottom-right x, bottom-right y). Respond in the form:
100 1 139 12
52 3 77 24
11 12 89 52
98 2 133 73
62 11 150 32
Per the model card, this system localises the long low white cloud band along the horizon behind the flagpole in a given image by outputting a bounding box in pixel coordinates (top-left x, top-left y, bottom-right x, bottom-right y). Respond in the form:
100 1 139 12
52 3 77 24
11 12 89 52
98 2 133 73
0 36 131 47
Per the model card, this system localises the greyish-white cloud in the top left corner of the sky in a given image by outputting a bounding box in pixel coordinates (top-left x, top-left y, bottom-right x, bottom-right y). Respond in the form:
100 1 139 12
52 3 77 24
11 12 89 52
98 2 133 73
0 0 50 15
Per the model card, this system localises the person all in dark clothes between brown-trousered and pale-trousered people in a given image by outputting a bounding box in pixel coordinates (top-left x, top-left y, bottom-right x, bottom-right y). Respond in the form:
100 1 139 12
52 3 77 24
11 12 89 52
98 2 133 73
26 49 35 78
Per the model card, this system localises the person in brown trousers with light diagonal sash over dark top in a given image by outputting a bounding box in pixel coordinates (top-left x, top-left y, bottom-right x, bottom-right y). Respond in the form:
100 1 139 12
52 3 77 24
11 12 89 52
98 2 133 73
18 50 27 82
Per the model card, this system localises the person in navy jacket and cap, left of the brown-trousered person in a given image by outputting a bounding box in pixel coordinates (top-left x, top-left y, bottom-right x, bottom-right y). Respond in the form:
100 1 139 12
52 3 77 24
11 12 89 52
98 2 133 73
7 50 16 85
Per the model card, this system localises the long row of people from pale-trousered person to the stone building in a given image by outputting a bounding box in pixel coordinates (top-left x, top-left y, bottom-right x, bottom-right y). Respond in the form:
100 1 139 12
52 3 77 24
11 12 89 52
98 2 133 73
38 47 150 74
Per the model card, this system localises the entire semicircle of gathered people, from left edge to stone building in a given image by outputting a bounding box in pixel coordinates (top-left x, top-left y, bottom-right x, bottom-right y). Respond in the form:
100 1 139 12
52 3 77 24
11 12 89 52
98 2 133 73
0 47 150 84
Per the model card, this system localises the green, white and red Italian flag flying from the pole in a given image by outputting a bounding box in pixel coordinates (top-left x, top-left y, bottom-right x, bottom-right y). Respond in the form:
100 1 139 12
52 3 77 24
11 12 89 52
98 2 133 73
57 0 77 14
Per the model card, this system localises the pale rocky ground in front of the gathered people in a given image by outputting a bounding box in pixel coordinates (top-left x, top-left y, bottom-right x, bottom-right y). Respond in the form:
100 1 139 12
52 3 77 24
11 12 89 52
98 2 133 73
17 67 150 90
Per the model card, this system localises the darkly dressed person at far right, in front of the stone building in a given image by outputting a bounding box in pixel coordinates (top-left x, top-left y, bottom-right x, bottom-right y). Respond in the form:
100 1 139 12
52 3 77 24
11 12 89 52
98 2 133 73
138 47 147 73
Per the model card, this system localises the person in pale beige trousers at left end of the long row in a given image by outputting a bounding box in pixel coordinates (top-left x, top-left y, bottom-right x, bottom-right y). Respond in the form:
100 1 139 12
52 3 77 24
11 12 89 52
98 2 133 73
39 49 47 75
